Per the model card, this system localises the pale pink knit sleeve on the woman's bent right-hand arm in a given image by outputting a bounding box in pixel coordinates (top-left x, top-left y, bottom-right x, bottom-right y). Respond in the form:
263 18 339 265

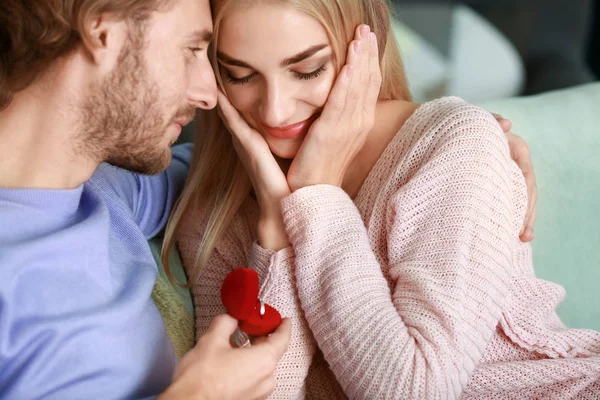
282 107 524 399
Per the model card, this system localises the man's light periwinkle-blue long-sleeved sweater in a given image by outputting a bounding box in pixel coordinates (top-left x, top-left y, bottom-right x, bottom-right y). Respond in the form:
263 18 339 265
0 145 191 400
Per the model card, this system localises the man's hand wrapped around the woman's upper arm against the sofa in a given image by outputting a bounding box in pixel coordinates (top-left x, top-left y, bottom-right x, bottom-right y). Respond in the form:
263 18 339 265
494 114 538 242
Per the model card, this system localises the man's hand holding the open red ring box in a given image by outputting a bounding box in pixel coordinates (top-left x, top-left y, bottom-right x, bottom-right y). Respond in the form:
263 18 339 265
159 315 291 400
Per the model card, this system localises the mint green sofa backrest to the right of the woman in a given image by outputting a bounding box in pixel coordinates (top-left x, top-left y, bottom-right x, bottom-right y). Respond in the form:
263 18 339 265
480 83 600 330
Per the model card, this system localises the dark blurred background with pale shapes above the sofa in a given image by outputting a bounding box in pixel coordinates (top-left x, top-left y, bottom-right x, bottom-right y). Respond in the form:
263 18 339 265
392 0 600 102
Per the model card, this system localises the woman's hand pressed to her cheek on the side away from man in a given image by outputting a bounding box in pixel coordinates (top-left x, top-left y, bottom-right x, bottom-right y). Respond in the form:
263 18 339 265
287 25 381 191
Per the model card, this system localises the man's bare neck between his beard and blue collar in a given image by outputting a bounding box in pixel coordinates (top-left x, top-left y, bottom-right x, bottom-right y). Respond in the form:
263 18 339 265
0 80 99 189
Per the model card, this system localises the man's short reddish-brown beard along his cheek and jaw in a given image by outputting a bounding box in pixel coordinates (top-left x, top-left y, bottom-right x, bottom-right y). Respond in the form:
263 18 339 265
77 29 195 175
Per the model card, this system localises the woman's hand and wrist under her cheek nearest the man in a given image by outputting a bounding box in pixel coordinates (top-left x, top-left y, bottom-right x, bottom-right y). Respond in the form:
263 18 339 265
218 90 290 251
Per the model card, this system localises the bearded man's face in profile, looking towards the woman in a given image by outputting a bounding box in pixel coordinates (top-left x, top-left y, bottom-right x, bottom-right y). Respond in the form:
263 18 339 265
81 0 217 174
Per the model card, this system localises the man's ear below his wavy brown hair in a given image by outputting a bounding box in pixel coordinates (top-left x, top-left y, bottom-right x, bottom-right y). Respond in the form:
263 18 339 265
81 13 128 70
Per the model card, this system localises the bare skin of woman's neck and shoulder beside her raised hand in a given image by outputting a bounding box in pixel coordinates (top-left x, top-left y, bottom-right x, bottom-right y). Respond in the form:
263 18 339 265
342 100 419 199
